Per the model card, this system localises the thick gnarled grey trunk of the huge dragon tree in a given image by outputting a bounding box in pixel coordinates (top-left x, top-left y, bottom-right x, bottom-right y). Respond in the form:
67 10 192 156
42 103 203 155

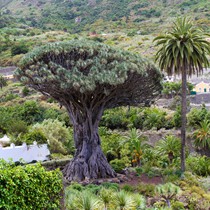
63 104 116 181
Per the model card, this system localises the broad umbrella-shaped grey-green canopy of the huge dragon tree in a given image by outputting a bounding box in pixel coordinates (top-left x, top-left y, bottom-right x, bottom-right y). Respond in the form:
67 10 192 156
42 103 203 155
16 40 161 110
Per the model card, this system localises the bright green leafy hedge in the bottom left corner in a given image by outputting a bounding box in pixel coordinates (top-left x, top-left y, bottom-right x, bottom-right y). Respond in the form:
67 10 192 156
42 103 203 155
0 161 62 210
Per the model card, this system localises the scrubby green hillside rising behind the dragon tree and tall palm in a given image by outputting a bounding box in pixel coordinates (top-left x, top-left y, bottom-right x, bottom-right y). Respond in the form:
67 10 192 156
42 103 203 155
0 0 210 66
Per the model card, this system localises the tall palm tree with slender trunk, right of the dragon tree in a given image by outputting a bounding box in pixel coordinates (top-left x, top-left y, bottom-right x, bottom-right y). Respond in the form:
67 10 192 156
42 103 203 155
154 18 210 172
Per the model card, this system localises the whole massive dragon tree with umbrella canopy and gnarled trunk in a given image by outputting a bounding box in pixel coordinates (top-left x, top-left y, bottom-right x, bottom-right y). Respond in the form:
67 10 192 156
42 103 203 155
16 40 162 181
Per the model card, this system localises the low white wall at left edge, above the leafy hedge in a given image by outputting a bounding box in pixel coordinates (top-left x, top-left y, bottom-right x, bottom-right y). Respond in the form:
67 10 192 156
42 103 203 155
0 142 50 163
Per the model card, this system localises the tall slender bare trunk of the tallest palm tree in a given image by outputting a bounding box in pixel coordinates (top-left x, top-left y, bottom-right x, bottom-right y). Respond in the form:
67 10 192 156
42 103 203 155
181 66 187 172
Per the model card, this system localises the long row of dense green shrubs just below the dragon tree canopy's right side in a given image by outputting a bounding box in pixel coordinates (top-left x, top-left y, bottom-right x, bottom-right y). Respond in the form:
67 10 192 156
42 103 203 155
101 107 173 130
